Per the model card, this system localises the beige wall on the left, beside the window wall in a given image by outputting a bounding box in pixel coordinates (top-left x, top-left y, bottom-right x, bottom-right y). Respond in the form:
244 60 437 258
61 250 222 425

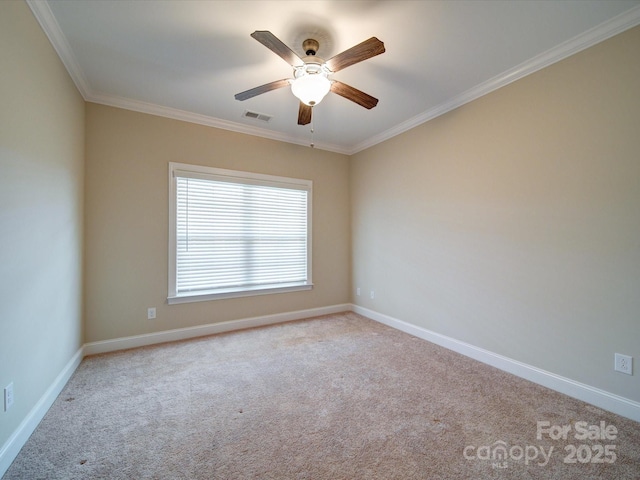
0 1 84 448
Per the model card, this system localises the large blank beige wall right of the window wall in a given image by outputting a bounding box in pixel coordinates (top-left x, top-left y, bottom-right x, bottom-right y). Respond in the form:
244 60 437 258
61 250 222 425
351 27 640 401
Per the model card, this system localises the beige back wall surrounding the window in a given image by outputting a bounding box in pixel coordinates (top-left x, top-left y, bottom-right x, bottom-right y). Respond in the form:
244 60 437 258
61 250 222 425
85 104 350 342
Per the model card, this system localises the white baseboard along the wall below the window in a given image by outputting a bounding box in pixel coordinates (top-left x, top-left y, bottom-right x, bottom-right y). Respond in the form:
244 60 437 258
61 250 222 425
84 304 351 355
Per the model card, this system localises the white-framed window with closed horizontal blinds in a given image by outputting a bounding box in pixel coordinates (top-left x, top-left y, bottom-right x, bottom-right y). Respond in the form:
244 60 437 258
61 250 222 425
168 163 312 304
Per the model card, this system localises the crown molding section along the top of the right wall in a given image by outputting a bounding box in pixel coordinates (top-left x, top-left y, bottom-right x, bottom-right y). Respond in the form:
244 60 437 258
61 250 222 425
349 5 640 155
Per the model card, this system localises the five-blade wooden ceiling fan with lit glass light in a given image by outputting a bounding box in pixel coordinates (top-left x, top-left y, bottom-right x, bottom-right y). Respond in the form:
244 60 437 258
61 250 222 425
235 30 385 125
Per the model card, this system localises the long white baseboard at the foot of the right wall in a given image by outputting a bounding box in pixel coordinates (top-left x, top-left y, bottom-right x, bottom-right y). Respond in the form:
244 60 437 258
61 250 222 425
352 305 640 422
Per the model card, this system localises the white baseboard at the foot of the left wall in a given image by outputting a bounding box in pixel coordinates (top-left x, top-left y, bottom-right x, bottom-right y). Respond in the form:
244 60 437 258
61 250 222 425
0 348 83 478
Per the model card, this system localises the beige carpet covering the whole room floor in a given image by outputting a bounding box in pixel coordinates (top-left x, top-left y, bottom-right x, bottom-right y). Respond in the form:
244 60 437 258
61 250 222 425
5 313 640 480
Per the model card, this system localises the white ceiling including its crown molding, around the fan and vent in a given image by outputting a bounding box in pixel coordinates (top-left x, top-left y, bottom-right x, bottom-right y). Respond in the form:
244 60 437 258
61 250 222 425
28 0 640 154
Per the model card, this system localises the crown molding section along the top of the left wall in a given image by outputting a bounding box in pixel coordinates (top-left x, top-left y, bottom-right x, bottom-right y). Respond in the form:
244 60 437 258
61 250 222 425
26 0 91 100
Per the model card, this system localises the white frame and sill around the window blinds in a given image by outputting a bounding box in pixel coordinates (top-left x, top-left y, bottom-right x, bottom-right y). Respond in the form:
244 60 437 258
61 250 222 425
167 162 313 305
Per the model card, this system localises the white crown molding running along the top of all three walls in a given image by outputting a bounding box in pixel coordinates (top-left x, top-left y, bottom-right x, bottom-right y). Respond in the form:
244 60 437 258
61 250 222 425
26 0 640 155
